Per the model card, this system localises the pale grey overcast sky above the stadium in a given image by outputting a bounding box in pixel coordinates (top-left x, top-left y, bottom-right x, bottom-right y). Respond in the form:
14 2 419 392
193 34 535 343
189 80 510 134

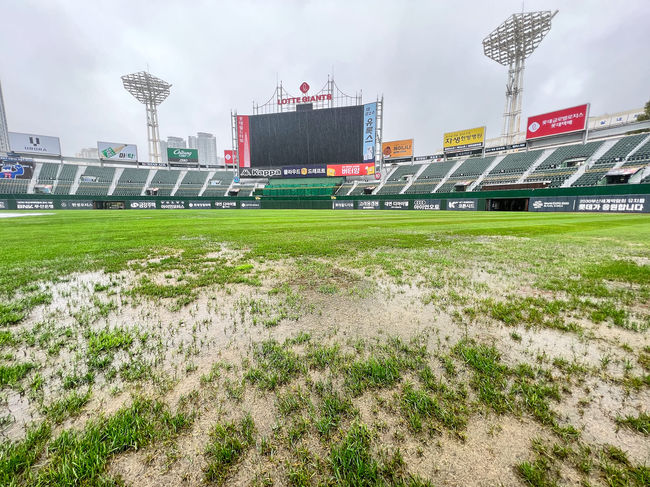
0 0 650 157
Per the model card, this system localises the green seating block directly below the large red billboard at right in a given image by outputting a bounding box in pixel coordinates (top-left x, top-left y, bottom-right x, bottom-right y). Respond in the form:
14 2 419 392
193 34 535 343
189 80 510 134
525 141 603 188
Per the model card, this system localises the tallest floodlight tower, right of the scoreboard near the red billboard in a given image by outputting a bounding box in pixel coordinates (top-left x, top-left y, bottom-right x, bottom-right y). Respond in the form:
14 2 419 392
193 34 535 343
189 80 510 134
483 10 558 143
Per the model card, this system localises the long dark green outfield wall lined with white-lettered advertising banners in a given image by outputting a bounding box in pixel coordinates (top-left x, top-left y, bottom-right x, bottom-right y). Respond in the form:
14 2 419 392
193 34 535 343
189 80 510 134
0 184 650 213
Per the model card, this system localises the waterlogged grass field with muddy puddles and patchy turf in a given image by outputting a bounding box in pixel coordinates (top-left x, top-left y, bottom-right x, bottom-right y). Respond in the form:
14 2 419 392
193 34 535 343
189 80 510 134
0 210 650 486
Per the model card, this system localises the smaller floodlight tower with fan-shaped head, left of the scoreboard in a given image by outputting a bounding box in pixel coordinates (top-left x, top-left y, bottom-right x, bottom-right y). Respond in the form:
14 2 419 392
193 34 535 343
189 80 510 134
122 71 172 162
